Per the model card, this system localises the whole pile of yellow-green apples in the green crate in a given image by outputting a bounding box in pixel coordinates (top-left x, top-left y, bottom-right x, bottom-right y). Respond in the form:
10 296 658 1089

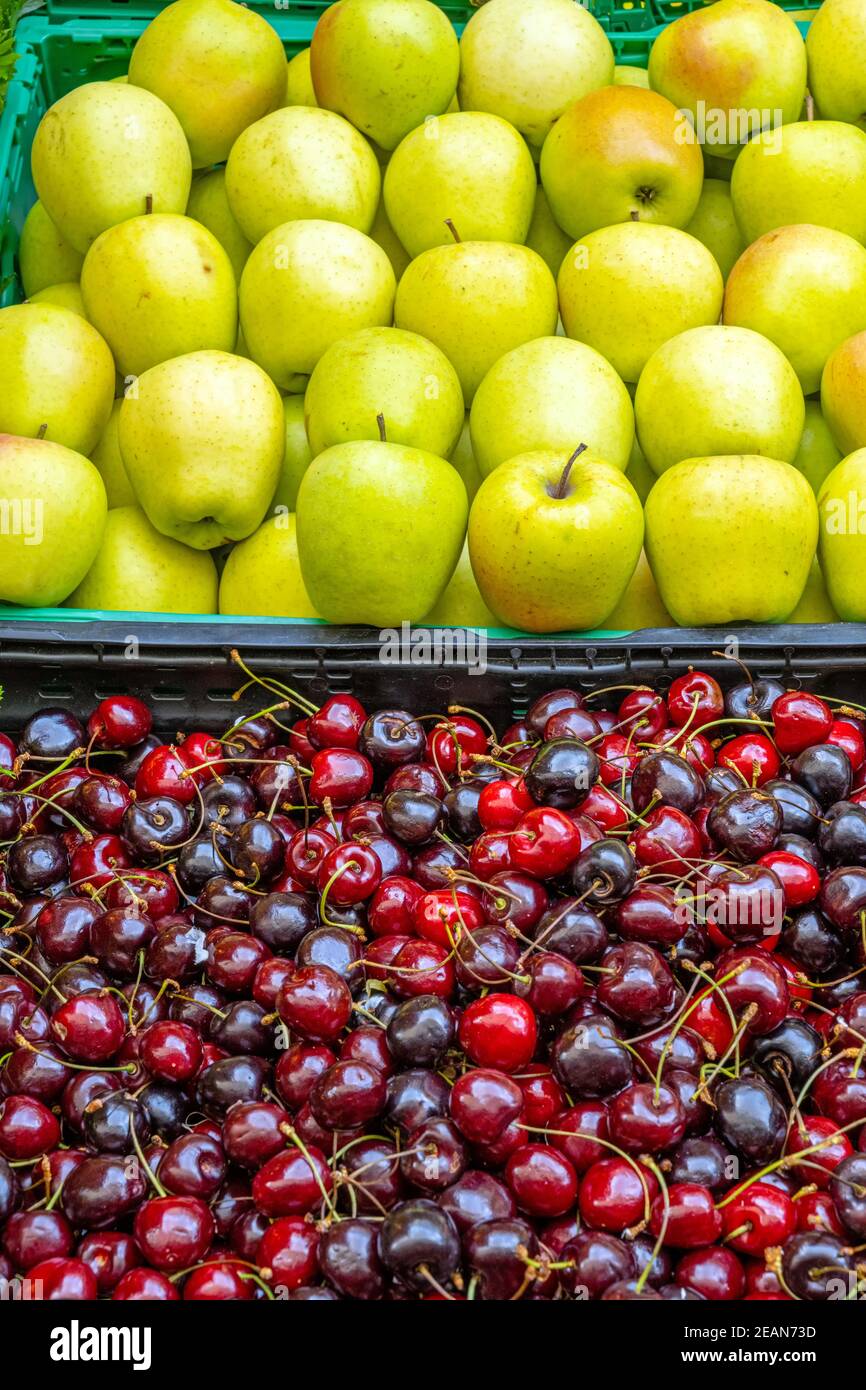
0 0 866 631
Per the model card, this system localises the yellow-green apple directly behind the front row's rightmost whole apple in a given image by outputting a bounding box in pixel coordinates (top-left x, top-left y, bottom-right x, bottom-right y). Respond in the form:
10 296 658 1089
634 324 805 474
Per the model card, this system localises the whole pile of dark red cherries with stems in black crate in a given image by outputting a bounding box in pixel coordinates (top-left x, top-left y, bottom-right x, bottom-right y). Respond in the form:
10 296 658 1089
0 653 866 1300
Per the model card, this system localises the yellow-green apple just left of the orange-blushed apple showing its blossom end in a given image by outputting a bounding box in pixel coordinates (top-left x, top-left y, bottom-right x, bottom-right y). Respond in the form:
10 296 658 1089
384 111 537 256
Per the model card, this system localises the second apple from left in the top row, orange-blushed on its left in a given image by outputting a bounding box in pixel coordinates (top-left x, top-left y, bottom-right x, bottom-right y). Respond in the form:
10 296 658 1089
310 0 460 150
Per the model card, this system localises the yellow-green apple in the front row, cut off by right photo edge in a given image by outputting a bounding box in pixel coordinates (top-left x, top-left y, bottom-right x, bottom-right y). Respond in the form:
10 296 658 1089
817 449 866 623
